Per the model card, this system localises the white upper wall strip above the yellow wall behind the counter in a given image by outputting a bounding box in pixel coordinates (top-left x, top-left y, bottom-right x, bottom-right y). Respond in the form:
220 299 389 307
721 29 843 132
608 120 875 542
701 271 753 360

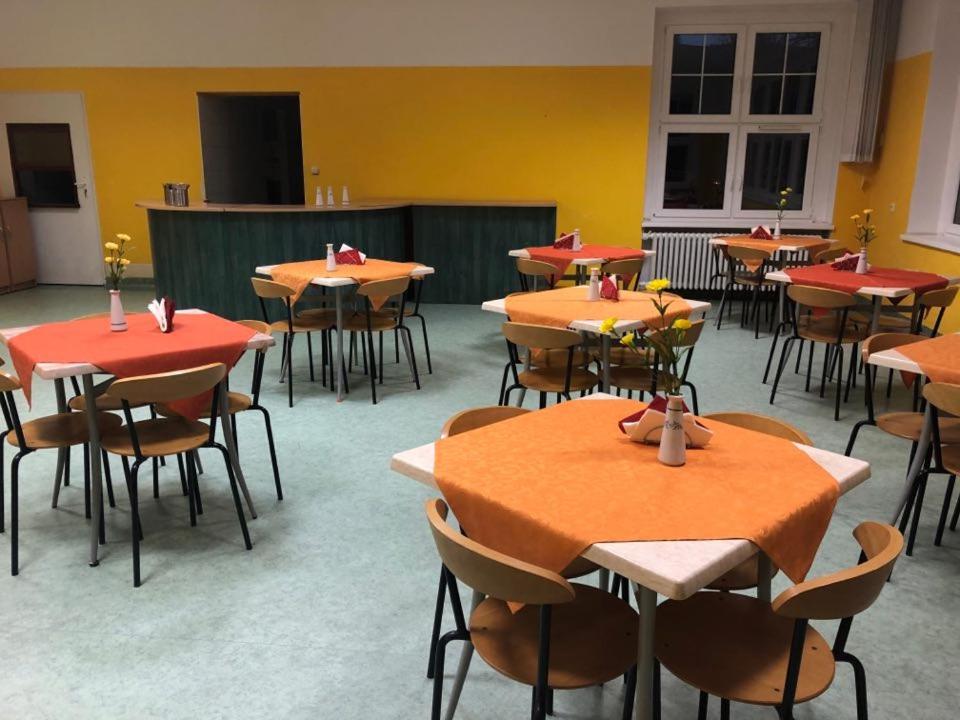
0 0 856 67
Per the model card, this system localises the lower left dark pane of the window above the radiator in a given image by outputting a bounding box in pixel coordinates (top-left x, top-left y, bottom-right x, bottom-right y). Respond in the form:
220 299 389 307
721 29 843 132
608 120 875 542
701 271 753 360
663 133 730 210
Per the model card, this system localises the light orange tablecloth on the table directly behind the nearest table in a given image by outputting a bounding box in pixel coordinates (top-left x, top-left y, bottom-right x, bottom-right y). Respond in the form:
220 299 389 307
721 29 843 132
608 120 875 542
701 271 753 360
506 285 690 328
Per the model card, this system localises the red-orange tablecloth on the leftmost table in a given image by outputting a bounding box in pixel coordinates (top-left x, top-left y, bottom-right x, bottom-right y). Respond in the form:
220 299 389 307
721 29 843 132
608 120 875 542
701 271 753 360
9 313 254 418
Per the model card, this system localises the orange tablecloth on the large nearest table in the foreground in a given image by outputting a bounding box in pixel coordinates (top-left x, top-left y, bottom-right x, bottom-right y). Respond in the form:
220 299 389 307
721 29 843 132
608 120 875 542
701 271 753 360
434 400 840 581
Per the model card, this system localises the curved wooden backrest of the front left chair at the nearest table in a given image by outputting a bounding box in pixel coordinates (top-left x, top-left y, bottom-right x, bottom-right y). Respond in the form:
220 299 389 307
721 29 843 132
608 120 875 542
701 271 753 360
427 499 576 605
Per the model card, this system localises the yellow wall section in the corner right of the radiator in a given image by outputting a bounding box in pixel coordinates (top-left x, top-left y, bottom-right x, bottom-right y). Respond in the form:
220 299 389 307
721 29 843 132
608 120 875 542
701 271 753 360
834 53 960 330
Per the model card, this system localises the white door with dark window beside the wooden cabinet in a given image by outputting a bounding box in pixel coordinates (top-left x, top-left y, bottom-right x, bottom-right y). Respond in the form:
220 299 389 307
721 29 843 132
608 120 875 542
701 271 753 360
0 92 104 285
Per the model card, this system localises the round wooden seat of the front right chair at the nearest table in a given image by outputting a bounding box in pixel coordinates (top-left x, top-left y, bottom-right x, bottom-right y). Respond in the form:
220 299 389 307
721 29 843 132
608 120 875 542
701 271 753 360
655 592 836 705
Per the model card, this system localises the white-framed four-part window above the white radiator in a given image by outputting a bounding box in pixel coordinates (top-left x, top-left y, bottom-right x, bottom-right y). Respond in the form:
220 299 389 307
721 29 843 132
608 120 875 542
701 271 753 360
644 8 852 227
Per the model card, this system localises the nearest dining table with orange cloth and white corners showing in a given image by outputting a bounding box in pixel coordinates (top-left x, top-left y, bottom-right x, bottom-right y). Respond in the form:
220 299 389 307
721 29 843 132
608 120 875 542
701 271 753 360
390 393 870 720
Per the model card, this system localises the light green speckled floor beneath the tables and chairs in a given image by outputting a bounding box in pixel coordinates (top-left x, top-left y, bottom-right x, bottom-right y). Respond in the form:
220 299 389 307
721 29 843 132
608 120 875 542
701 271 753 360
0 288 960 720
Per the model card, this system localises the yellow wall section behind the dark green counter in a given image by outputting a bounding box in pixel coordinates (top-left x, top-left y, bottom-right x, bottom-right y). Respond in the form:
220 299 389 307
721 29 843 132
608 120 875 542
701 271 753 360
0 67 650 262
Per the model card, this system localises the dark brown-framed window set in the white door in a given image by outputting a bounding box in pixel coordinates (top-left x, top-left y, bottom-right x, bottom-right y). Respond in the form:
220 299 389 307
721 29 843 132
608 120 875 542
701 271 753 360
7 123 80 208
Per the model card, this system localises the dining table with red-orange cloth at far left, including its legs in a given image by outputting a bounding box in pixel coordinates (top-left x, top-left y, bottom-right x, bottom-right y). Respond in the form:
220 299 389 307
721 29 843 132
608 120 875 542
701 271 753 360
0 309 275 567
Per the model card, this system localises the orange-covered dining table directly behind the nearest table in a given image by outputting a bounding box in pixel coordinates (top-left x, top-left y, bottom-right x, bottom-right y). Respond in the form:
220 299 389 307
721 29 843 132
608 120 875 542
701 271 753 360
480 285 710 390
